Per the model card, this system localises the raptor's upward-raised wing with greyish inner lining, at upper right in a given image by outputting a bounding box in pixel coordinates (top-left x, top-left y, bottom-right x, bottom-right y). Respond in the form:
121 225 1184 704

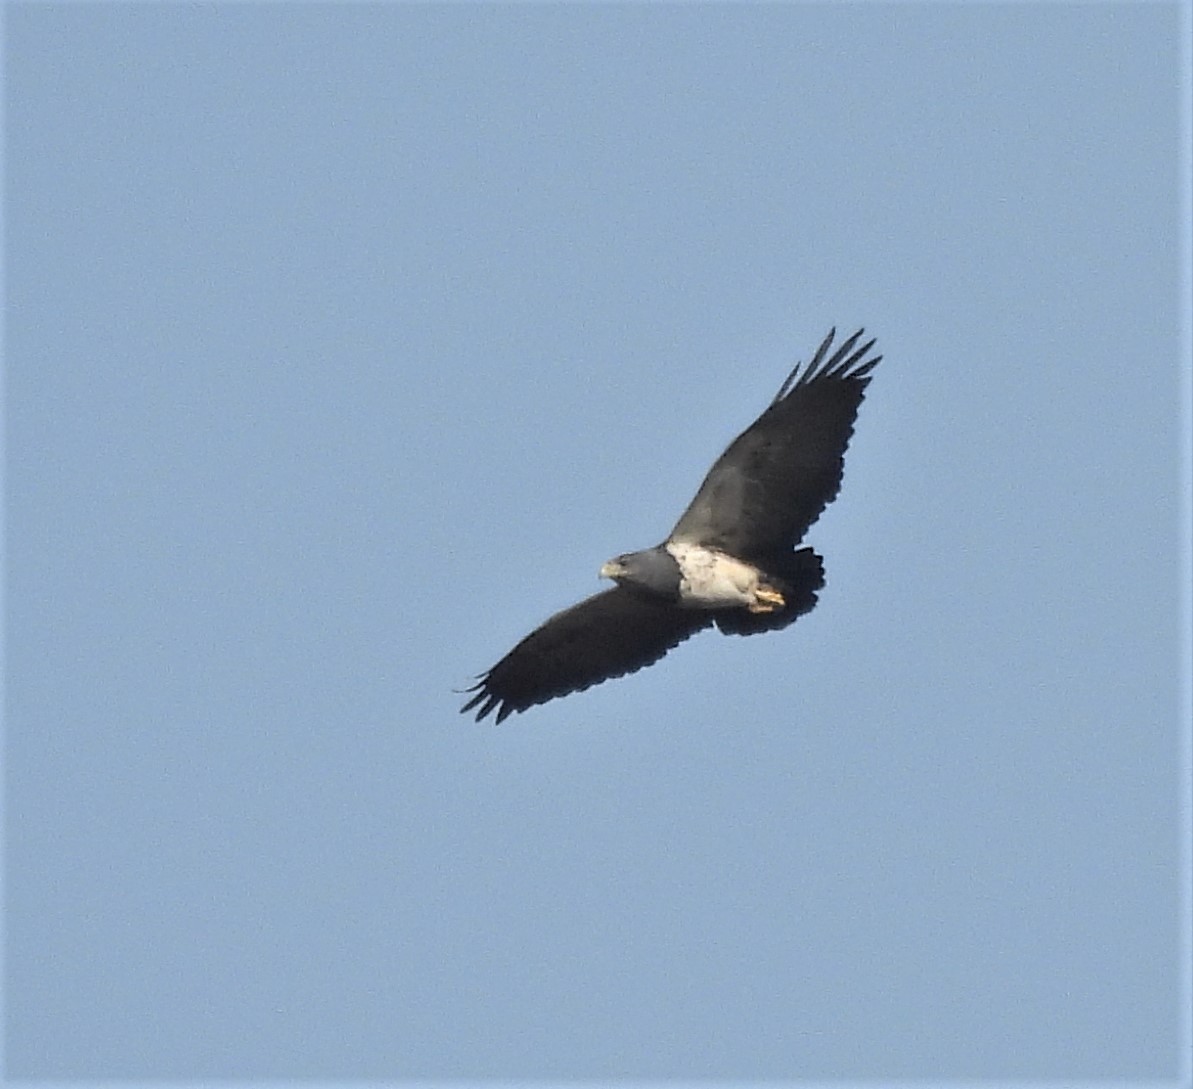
669 329 882 557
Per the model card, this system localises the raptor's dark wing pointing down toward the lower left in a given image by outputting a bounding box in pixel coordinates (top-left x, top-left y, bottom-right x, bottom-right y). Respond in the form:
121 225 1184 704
460 587 712 723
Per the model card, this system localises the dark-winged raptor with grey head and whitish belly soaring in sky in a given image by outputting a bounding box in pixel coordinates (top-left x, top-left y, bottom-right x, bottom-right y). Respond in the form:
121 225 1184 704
460 329 882 723
